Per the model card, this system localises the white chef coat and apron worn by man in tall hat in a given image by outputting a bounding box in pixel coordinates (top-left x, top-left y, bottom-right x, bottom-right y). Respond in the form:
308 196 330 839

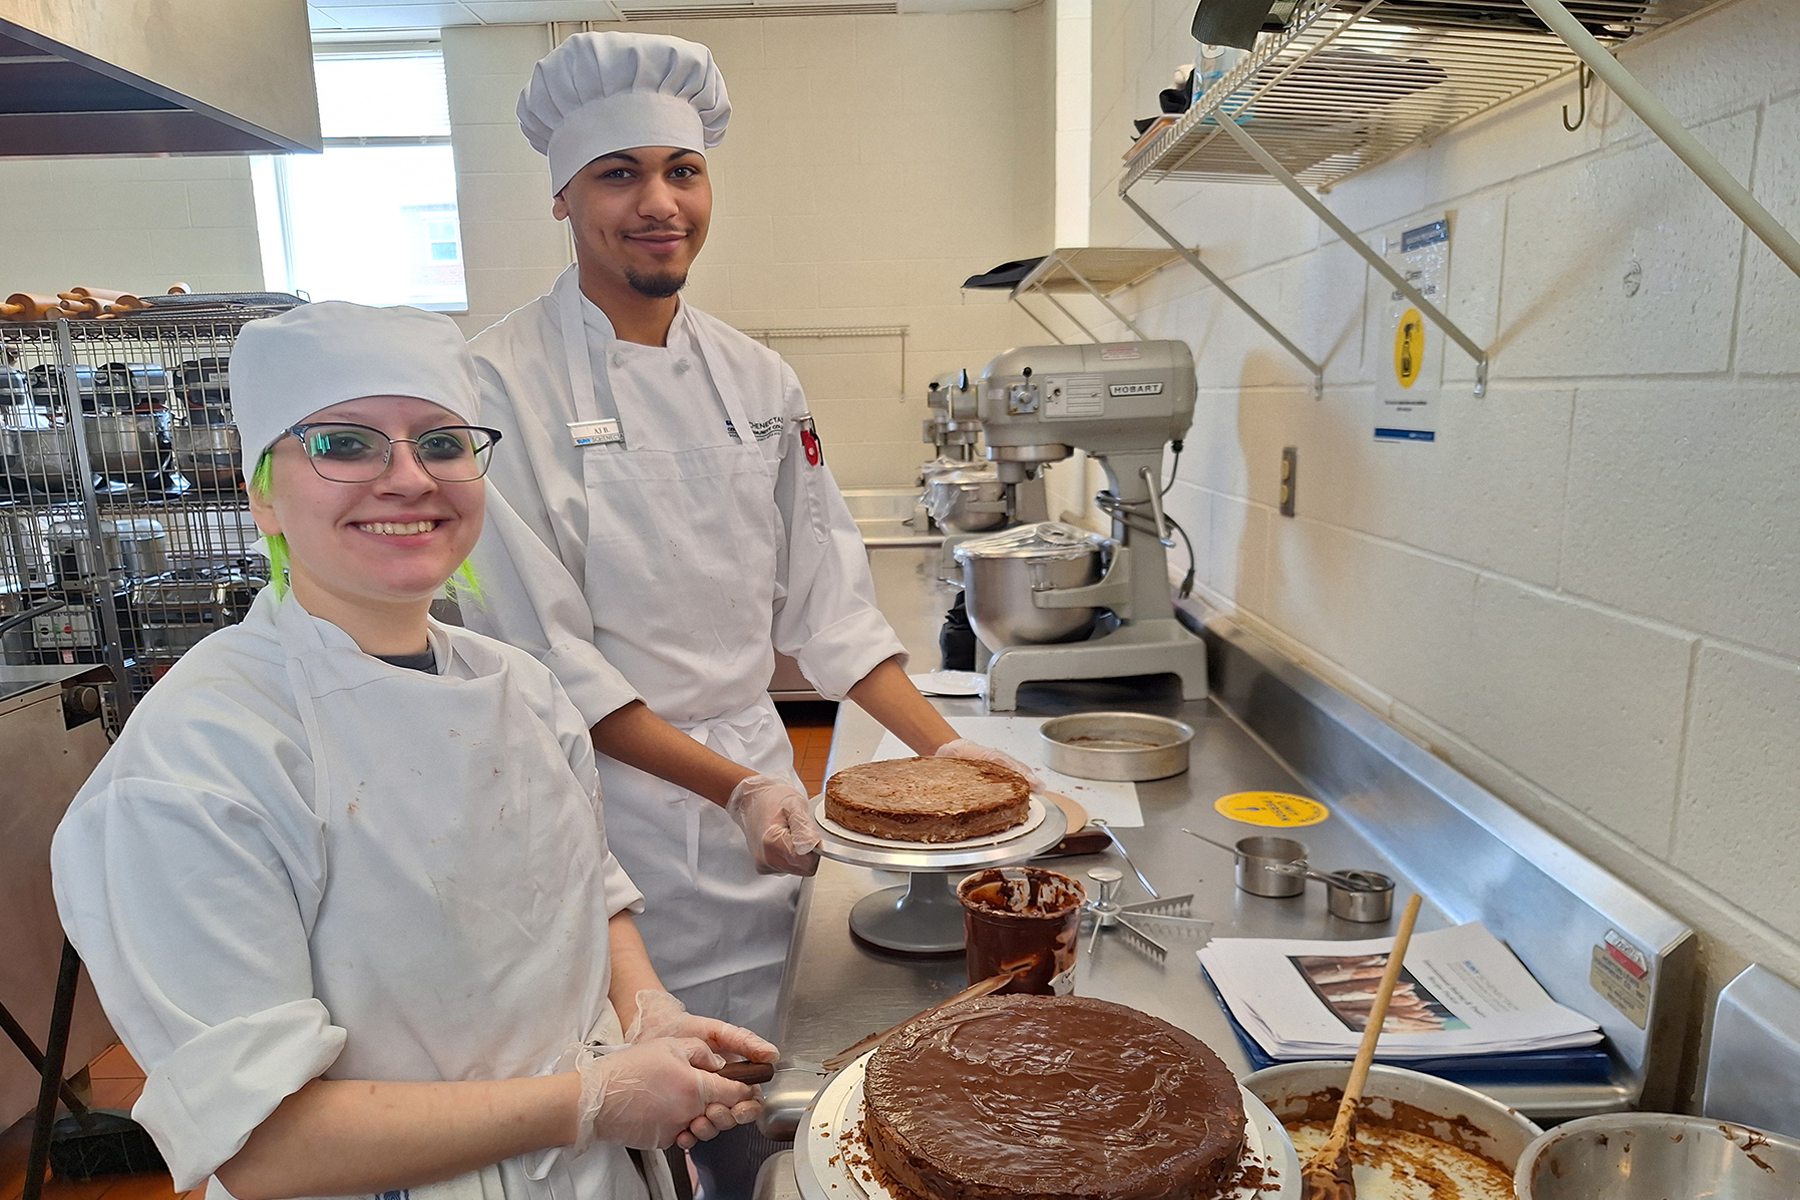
464 266 904 1034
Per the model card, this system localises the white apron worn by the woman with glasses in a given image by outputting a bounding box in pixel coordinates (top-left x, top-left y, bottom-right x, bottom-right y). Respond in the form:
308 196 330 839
262 597 666 1200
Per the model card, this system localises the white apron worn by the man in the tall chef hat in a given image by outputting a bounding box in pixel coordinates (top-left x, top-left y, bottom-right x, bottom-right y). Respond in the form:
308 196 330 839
554 266 799 1036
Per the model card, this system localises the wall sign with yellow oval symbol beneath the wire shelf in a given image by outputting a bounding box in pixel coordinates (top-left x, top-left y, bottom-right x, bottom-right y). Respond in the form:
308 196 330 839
1375 216 1451 443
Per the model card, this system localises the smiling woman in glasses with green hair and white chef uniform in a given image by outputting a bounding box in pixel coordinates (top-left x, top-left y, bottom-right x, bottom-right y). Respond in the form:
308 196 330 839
52 302 776 1200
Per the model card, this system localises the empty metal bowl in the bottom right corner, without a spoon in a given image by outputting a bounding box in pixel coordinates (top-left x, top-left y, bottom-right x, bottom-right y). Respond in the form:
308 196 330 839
1512 1112 1800 1200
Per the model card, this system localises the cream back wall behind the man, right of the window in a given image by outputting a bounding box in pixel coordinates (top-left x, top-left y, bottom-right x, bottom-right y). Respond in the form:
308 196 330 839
445 5 1055 486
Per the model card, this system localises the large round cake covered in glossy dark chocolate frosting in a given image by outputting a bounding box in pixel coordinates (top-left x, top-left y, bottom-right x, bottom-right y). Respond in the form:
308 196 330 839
862 995 1244 1200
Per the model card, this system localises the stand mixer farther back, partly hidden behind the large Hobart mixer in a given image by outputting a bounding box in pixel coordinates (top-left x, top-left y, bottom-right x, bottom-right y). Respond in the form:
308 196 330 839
914 369 1046 583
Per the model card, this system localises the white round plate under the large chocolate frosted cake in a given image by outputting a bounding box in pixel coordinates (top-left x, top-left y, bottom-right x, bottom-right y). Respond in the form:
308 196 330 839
794 1051 1305 1200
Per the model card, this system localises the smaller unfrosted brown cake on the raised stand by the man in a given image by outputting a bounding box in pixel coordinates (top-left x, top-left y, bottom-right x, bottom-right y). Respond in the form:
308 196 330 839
824 757 1031 842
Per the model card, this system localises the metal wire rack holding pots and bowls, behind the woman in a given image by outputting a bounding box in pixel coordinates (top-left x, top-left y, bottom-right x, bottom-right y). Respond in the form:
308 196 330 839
0 308 279 727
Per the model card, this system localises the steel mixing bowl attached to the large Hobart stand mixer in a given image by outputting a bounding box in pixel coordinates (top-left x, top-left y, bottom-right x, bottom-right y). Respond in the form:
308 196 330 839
956 522 1111 649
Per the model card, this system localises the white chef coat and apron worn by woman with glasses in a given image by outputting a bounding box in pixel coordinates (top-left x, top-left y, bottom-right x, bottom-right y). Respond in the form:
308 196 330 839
52 588 644 1200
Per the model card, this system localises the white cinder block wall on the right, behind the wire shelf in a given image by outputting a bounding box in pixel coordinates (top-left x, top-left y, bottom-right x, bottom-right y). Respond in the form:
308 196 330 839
1062 0 1800 1101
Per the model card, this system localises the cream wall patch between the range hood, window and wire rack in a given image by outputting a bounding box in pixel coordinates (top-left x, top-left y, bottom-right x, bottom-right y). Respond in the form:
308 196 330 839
0 155 263 295
